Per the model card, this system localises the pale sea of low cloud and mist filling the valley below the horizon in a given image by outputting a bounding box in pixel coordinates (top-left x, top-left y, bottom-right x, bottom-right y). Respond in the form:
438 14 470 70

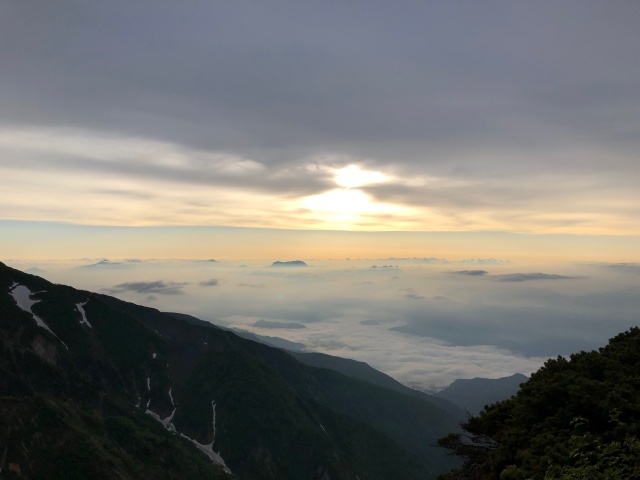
23 259 640 388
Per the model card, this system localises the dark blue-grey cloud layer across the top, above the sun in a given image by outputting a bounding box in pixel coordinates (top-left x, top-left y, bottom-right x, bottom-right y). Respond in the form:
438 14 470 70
0 1 640 161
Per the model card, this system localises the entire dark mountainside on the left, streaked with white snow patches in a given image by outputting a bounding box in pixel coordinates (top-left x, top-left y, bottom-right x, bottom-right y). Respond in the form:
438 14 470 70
0 264 462 479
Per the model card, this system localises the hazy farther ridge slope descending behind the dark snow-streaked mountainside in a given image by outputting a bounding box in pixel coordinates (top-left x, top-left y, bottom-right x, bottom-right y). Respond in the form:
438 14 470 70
112 297 461 472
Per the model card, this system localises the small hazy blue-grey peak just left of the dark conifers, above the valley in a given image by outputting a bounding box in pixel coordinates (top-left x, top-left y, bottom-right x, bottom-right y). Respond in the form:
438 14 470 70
436 373 528 415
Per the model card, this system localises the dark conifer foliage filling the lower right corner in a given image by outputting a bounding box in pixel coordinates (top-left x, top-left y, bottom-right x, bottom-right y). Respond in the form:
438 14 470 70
438 327 640 480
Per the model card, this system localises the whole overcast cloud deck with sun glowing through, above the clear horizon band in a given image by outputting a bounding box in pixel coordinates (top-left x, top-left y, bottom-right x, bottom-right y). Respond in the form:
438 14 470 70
0 0 640 233
